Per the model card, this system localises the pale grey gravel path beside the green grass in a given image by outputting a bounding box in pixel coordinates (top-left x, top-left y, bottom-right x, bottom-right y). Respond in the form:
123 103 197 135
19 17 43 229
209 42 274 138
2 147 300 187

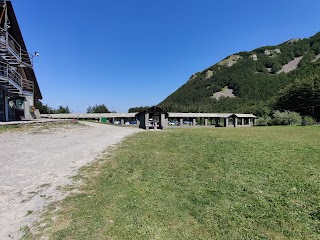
0 123 141 240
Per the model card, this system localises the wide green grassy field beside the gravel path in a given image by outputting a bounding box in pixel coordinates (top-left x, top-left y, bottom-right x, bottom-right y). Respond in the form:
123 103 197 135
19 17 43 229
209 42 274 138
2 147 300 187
29 127 320 239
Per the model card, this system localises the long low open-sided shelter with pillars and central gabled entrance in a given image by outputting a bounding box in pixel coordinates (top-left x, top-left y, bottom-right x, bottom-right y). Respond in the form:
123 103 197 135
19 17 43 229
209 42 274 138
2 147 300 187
41 106 256 130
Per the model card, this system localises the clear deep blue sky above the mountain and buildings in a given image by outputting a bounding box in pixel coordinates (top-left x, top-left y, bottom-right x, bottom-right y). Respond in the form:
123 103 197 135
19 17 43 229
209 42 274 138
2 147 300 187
12 0 320 113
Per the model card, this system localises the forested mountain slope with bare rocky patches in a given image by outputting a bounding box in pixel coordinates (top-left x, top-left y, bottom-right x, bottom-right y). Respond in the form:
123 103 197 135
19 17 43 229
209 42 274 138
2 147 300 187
159 32 320 116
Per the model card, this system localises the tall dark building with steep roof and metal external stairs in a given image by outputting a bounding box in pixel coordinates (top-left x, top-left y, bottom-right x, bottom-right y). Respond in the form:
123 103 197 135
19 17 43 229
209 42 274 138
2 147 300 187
0 0 42 122
